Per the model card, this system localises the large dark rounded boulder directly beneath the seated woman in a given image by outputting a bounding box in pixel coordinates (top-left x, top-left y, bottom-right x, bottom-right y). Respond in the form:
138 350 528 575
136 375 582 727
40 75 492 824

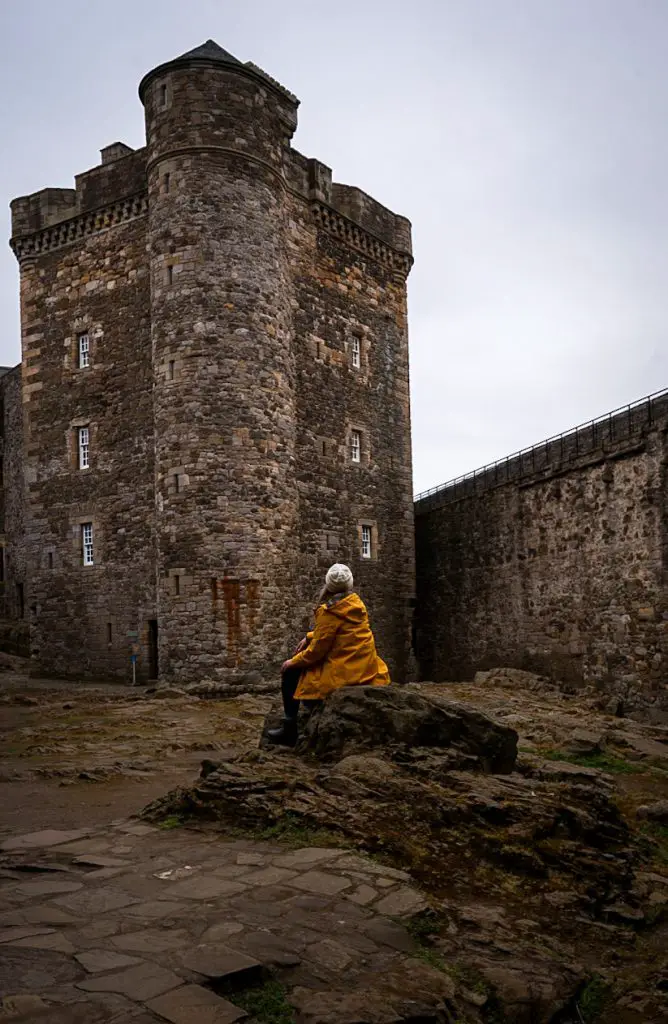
297 686 517 773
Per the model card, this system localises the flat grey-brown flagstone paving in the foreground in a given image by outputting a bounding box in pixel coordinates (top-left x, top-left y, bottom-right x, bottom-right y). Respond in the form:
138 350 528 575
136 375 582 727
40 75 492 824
0 819 448 1024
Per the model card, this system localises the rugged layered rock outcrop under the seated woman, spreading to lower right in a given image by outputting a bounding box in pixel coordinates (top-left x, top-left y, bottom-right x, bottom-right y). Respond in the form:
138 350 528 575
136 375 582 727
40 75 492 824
141 685 668 1024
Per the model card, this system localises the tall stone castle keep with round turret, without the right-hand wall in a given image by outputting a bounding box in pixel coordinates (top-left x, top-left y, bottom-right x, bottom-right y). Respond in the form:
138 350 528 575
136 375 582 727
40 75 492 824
0 41 414 692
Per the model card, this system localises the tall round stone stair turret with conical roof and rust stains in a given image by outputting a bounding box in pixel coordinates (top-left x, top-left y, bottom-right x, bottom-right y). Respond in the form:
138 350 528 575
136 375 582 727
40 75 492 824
139 41 298 686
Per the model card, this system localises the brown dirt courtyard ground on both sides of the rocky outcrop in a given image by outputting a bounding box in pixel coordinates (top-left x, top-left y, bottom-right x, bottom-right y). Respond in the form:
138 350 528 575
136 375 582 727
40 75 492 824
0 655 668 833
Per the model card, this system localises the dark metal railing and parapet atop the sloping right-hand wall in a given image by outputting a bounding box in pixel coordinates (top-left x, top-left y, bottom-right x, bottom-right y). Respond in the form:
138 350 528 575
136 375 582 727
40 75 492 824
414 388 668 503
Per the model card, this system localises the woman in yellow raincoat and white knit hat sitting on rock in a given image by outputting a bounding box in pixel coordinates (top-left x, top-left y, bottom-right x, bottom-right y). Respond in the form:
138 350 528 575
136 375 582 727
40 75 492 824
266 563 389 746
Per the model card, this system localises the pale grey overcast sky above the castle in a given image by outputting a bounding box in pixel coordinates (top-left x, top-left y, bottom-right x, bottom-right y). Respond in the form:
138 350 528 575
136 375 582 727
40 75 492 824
0 0 668 490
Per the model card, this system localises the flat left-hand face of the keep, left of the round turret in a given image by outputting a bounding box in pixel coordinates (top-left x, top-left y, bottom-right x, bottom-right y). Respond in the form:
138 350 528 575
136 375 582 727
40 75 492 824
12 157 156 678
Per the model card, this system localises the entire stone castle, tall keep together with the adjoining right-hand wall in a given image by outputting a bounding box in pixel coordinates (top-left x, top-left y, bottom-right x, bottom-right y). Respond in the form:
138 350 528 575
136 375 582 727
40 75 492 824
0 41 668 717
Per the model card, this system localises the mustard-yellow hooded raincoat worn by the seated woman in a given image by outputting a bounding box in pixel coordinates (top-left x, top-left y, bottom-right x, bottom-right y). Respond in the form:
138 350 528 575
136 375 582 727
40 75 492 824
290 594 389 700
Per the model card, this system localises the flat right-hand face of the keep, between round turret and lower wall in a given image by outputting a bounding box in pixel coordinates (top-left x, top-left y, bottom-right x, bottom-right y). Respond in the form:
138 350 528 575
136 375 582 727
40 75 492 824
292 165 415 681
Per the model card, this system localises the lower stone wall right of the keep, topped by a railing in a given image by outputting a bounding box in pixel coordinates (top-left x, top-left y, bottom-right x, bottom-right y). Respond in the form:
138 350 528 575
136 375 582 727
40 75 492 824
415 398 668 705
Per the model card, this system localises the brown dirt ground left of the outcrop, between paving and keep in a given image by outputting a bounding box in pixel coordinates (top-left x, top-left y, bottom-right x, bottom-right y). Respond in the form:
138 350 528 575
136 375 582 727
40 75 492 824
0 663 270 834
